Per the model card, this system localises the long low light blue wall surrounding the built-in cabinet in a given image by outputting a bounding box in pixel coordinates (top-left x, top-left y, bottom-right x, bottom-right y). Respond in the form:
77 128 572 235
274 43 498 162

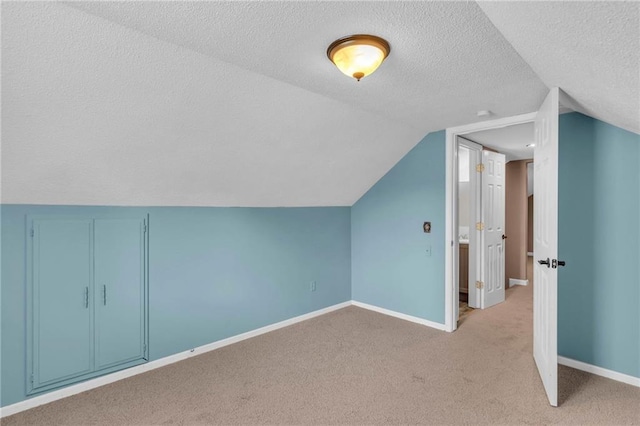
1 205 351 406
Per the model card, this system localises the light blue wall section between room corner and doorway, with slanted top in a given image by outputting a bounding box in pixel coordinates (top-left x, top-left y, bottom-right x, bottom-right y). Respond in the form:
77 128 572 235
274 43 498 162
351 131 445 323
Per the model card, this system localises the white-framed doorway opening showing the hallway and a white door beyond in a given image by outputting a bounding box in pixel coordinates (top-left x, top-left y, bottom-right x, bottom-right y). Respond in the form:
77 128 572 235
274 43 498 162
445 113 536 331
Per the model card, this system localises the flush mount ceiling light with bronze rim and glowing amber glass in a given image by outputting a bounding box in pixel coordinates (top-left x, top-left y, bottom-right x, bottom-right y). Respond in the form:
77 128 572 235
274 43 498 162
327 34 391 81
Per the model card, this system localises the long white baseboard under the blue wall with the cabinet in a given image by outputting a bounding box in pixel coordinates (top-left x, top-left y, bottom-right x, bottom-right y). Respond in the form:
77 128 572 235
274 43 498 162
0 301 351 418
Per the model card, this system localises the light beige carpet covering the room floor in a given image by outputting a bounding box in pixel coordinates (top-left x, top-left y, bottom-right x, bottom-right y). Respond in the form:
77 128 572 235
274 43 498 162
2 286 640 426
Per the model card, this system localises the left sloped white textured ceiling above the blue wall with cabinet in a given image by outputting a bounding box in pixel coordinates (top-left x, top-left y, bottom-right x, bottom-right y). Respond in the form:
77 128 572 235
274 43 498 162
2 2 425 206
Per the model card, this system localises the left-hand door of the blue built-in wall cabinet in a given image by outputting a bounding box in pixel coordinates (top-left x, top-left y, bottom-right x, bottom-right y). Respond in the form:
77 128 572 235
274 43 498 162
30 220 93 388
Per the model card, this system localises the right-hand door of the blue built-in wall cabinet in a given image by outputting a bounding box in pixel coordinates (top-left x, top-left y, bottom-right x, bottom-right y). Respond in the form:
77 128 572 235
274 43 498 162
94 219 145 370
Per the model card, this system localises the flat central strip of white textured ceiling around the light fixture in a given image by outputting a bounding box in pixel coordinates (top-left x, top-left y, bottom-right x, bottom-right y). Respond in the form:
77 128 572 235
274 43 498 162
63 1 546 131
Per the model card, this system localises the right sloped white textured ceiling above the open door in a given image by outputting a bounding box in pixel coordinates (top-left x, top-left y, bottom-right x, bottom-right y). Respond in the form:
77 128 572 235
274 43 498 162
479 1 640 133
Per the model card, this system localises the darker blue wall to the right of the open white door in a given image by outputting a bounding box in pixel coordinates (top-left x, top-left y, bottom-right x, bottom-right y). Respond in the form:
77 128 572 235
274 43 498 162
558 113 640 377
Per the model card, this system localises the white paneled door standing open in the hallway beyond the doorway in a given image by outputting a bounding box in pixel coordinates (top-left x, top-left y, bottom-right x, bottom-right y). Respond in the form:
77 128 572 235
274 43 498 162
481 151 505 309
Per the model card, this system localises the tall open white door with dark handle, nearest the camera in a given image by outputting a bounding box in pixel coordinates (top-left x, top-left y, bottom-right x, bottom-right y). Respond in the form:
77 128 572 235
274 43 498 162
533 88 559 407
